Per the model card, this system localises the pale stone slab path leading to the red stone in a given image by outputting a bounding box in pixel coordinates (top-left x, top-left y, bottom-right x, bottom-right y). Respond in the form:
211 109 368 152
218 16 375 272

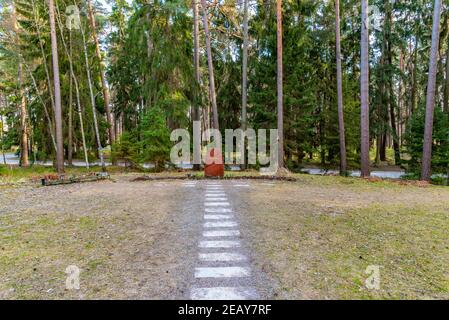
188 181 259 300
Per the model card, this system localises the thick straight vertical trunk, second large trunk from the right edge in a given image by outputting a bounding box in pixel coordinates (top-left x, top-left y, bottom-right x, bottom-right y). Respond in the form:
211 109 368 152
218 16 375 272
360 0 370 178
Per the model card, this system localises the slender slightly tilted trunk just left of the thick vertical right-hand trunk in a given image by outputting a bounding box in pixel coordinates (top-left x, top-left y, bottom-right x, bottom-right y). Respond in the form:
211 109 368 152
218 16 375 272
335 0 347 176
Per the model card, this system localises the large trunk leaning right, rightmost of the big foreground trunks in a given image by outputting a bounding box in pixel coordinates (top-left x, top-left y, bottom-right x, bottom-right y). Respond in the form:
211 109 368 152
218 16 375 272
421 0 442 181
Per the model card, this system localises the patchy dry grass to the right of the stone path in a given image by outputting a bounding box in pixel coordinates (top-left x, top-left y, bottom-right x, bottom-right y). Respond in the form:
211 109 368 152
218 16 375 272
243 176 449 299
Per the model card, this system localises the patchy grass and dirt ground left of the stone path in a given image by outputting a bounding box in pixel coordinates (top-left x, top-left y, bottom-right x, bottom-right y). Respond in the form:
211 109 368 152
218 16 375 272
0 177 200 299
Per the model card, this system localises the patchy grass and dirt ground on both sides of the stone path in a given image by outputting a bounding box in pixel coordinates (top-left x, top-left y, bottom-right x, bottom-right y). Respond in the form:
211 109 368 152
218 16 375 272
0 174 449 299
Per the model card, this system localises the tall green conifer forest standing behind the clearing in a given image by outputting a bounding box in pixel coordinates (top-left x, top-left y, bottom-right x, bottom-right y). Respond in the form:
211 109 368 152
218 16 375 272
0 0 449 180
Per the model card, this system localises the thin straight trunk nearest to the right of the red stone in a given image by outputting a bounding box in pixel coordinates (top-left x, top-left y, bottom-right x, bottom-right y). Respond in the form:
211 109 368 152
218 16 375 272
242 0 249 170
